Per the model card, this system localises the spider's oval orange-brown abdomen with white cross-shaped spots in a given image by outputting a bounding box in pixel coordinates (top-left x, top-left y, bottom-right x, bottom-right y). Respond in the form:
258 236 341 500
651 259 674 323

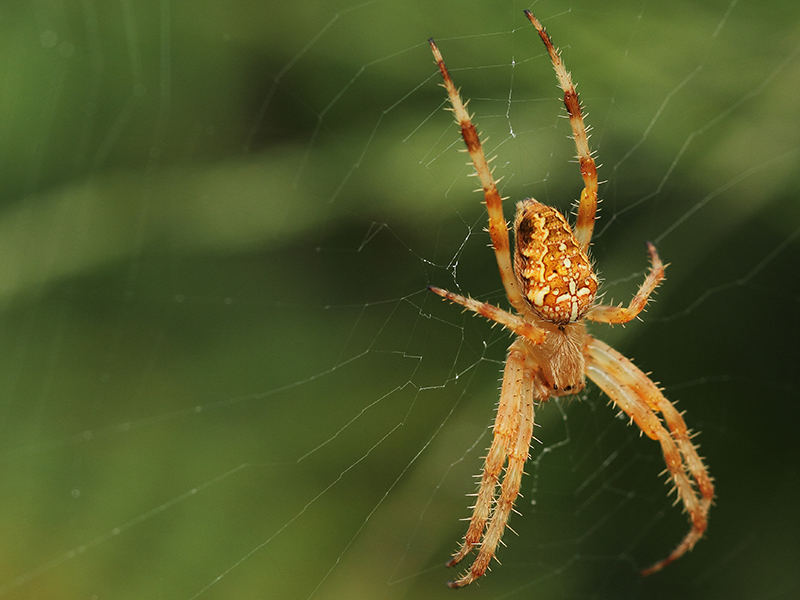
514 198 597 325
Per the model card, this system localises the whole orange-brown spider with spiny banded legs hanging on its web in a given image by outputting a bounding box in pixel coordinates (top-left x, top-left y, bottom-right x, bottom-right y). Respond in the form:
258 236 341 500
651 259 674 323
428 10 714 588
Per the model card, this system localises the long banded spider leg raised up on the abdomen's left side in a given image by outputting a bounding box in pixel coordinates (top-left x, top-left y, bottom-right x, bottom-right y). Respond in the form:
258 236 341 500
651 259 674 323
428 38 525 312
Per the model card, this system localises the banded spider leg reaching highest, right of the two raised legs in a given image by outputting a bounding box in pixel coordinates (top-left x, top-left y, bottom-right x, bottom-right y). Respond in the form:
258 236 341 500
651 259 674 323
525 10 597 252
